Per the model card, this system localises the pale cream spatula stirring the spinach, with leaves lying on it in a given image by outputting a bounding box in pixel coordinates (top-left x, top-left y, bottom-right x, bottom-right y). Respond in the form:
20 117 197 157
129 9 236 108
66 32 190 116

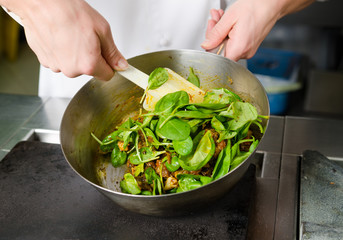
117 65 205 111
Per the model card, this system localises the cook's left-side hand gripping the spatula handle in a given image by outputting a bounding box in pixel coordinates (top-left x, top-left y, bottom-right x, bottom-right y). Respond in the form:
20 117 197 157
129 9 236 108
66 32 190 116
5 0 127 80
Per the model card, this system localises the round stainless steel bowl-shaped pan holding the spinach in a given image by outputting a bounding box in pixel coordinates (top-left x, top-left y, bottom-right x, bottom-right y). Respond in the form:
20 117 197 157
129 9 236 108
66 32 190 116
60 50 269 216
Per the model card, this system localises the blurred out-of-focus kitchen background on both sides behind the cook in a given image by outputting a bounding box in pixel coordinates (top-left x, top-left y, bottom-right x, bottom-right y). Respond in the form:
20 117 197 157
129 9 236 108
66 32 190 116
0 0 343 118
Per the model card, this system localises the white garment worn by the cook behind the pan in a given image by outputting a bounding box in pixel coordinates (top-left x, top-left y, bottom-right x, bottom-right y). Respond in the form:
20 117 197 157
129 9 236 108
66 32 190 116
38 0 232 98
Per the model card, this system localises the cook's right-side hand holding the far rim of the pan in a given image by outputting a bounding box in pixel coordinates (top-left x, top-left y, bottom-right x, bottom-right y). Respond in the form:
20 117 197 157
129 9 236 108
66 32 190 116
201 0 314 61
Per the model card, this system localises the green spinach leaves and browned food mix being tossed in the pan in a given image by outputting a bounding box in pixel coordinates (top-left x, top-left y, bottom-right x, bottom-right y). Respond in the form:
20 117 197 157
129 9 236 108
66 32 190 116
91 68 268 195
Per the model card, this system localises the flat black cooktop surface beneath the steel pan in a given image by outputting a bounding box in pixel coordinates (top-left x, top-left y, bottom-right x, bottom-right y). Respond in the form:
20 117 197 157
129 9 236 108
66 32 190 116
0 141 256 239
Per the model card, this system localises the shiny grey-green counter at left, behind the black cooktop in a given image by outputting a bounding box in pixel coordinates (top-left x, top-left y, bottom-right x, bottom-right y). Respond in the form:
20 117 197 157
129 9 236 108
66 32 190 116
0 94 70 160
